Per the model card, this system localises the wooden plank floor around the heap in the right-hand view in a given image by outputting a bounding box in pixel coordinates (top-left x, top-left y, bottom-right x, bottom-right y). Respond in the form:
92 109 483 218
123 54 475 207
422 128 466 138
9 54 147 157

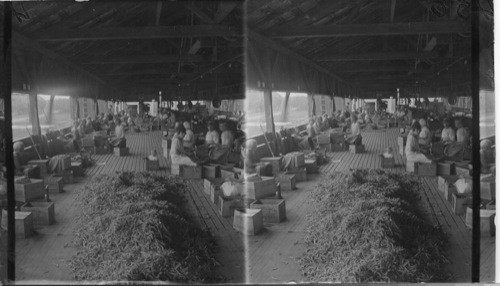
248 128 495 283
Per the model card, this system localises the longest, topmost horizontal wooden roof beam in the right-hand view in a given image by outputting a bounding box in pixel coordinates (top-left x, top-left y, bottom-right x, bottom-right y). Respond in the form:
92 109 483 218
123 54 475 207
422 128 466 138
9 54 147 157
270 21 471 38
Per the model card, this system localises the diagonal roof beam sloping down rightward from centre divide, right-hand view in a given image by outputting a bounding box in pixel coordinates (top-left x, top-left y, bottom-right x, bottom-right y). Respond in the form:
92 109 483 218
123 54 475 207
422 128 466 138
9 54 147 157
247 29 344 82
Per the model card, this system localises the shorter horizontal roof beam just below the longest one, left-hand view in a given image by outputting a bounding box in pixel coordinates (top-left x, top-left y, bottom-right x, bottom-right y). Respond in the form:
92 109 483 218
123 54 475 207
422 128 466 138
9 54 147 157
82 55 205 65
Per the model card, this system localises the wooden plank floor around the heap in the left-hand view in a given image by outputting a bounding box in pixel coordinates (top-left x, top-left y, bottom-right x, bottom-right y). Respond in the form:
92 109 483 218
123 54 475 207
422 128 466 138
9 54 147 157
16 131 245 283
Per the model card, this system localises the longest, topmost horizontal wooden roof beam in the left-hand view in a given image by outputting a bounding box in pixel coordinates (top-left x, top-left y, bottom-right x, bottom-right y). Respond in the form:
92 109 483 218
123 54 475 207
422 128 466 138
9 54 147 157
36 25 242 41
